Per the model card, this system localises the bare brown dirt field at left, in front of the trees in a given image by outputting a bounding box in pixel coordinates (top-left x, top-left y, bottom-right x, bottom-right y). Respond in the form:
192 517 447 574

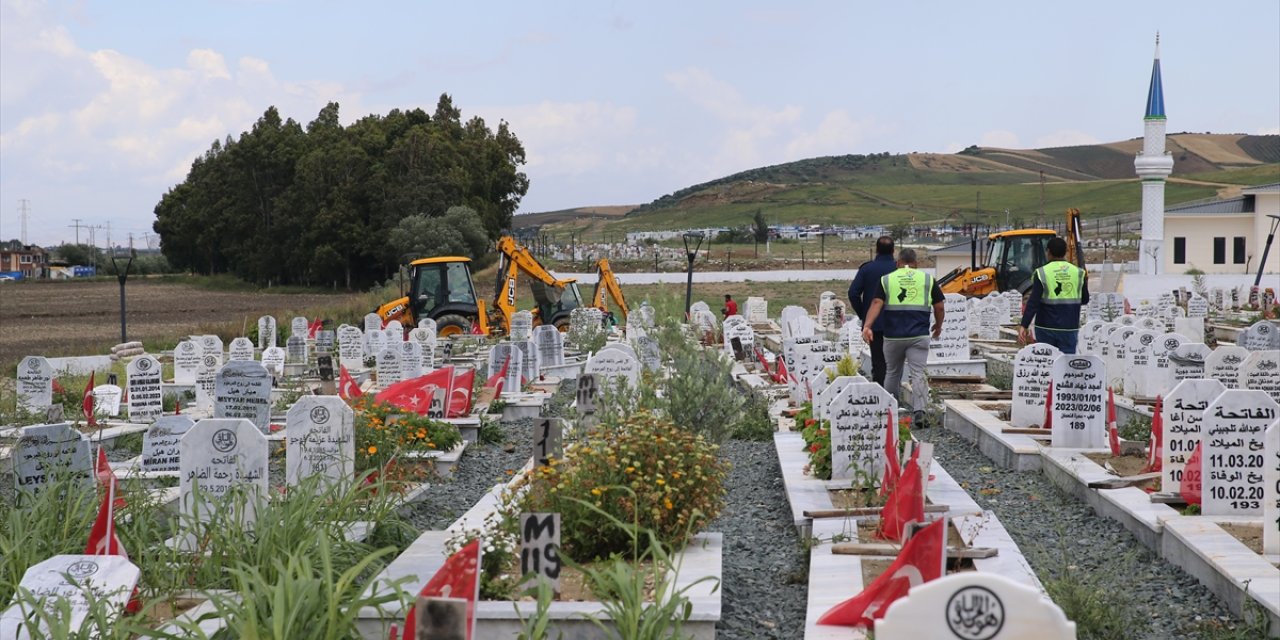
0 279 362 376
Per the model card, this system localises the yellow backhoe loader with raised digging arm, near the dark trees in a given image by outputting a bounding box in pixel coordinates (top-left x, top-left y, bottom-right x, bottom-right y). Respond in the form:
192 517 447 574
375 236 582 337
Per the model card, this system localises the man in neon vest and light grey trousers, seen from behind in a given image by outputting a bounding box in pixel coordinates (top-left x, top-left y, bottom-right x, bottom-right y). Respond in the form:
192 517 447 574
863 248 946 426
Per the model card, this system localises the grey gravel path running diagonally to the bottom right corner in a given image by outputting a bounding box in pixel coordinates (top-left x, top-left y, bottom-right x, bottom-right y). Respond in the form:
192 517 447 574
915 429 1238 640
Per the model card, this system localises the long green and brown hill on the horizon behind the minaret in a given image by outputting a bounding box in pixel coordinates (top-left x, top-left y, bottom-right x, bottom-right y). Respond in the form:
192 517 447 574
520 133 1280 232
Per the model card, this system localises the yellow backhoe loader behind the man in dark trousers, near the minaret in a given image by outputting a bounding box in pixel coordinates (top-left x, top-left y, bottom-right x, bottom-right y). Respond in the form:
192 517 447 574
938 209 1084 298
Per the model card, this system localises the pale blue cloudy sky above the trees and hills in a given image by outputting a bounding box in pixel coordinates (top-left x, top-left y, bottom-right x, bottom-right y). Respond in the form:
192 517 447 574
0 0 1280 247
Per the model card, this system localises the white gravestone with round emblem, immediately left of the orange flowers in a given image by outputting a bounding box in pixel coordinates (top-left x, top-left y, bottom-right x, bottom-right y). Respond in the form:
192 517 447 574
284 396 356 486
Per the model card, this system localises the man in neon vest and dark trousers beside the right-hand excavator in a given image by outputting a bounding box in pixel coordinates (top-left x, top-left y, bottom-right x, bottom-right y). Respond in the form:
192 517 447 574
1018 237 1089 353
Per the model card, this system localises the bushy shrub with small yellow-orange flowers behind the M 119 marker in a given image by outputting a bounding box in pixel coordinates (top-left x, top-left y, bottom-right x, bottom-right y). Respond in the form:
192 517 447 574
518 412 728 561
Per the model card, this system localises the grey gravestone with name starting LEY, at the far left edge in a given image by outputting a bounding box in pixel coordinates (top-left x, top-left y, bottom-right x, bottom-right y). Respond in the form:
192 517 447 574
10 422 93 494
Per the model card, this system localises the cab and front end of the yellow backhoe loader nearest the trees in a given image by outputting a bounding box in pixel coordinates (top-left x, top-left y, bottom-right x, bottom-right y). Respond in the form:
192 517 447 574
376 256 480 337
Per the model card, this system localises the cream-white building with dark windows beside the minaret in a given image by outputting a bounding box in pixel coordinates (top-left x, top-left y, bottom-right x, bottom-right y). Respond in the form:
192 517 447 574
1167 183 1280 276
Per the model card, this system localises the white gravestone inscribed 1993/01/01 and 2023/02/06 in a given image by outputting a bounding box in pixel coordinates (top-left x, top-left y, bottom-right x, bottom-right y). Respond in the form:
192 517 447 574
1052 356 1107 449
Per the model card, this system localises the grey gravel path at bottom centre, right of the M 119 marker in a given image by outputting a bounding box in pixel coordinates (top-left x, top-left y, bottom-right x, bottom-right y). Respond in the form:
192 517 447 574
708 440 809 640
